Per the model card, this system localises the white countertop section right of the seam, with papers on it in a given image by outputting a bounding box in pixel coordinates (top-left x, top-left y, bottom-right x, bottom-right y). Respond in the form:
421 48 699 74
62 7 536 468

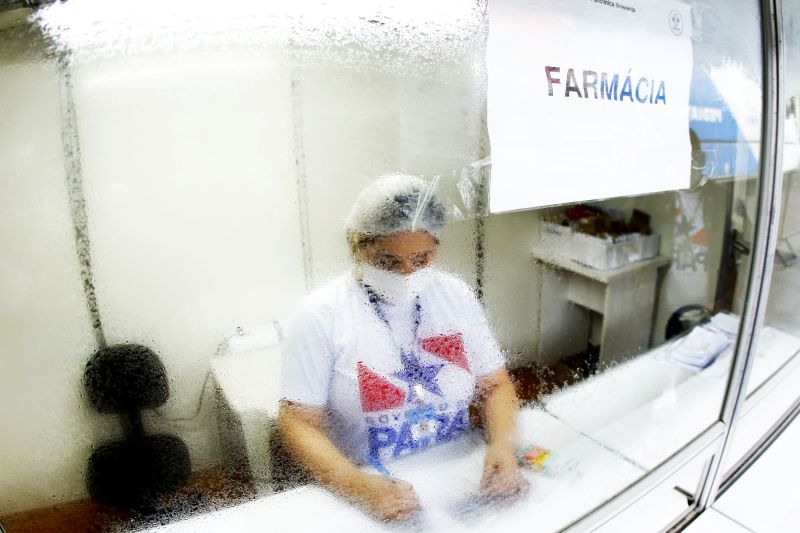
545 318 800 470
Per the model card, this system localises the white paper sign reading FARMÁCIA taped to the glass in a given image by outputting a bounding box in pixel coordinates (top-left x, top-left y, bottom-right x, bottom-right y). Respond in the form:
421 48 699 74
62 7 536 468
487 0 692 212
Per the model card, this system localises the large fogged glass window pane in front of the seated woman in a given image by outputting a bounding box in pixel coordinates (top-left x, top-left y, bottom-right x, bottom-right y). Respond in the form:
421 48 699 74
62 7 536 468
0 0 776 533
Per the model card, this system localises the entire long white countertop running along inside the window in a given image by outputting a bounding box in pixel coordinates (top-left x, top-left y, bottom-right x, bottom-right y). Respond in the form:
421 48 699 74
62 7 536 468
141 318 800 533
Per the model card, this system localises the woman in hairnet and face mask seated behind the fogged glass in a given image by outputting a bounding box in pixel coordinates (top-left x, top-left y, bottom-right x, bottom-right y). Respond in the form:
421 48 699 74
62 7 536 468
278 175 527 520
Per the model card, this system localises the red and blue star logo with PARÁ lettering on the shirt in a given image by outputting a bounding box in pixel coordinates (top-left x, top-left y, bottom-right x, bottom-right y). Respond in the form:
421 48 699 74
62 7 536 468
356 334 472 460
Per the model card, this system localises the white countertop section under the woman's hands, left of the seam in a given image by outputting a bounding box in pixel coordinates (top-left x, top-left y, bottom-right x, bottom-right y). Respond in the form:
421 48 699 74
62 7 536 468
139 409 644 533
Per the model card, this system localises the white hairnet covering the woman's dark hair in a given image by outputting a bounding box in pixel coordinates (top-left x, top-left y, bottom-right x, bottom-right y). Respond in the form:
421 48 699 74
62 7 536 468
345 174 445 239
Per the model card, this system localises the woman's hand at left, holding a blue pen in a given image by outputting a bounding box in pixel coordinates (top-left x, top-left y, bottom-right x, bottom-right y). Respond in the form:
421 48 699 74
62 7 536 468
354 474 420 522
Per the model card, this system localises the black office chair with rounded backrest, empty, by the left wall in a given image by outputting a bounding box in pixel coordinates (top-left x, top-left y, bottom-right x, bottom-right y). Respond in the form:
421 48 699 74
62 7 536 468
83 344 192 514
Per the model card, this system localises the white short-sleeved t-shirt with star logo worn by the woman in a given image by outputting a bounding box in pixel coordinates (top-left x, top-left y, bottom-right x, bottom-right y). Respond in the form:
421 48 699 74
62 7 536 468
281 268 504 464
